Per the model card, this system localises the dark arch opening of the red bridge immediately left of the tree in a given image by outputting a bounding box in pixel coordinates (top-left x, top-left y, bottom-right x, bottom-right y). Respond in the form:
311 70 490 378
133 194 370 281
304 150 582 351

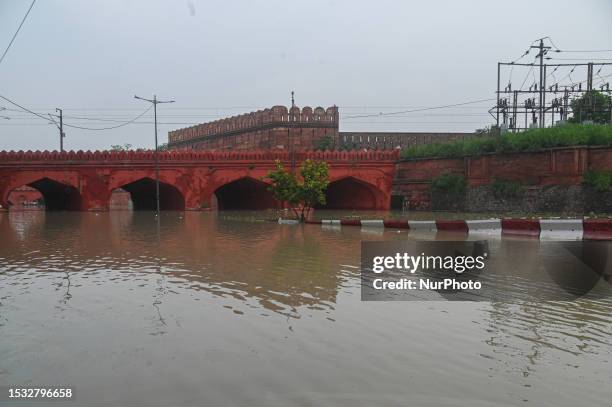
213 176 280 210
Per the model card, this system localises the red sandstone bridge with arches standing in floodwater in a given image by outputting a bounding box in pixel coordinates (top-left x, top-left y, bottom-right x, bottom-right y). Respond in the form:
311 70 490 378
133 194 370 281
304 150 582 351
0 150 399 211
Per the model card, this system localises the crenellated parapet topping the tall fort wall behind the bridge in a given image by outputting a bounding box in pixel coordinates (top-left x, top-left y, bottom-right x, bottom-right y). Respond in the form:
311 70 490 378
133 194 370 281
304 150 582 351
168 106 339 147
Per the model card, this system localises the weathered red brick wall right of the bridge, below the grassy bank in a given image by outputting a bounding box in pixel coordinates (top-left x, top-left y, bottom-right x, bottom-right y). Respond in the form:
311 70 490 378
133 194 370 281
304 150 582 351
393 147 612 209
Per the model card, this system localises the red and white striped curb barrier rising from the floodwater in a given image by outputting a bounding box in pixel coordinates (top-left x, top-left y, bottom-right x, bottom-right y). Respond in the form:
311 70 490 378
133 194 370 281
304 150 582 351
306 219 612 240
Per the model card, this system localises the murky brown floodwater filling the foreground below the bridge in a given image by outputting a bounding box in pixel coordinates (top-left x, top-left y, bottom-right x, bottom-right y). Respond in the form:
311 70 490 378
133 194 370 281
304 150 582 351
0 211 612 407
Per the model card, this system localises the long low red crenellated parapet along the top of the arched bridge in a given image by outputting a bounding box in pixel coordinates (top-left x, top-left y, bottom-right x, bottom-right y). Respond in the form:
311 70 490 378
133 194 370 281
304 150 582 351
0 149 399 163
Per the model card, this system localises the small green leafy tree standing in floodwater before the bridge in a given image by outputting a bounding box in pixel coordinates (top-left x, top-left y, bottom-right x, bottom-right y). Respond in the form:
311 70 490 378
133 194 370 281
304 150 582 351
267 160 329 222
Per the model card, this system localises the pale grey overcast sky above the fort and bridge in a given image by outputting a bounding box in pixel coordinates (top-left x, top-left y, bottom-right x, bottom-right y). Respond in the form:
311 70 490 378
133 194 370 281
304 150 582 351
0 0 612 150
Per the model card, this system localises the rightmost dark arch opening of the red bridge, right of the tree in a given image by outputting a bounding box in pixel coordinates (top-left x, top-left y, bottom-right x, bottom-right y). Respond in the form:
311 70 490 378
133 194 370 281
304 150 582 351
323 176 383 210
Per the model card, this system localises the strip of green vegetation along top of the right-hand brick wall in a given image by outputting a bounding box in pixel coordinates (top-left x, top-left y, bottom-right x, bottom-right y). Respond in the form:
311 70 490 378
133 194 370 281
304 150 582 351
402 124 612 159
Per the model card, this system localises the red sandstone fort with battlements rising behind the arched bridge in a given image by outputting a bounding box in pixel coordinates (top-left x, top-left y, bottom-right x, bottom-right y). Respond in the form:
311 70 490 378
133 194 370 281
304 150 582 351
168 106 475 150
